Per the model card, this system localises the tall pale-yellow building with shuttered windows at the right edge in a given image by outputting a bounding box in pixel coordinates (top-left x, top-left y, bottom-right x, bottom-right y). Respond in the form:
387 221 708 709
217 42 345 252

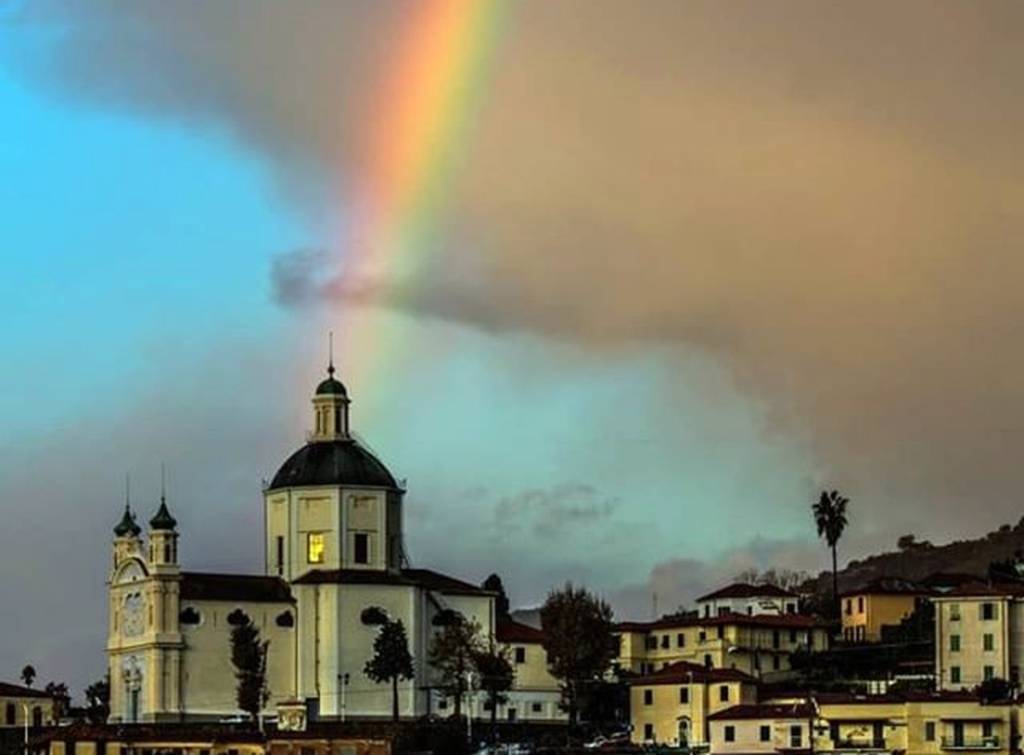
932 582 1024 689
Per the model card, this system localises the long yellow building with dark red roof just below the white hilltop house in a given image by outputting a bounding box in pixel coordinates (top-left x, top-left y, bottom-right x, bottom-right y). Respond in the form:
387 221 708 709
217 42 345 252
616 614 828 680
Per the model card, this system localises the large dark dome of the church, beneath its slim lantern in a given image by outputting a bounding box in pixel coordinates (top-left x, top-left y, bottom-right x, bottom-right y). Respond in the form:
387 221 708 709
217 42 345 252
268 438 398 490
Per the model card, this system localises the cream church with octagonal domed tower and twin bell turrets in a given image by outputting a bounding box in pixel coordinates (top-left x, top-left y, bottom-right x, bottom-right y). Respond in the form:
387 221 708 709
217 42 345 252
106 363 562 723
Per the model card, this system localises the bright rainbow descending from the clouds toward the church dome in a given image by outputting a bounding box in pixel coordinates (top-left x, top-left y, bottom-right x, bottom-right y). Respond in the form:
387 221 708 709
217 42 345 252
337 0 508 389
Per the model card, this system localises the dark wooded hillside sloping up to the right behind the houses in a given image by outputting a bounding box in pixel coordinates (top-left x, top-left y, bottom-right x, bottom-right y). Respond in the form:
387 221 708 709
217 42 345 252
808 518 1024 591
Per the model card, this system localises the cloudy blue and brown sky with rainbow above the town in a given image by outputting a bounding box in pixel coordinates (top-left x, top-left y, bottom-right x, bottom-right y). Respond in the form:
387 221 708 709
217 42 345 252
0 0 1024 691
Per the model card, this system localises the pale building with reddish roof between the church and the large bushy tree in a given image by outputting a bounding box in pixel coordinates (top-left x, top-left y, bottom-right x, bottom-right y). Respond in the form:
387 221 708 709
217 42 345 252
491 617 568 722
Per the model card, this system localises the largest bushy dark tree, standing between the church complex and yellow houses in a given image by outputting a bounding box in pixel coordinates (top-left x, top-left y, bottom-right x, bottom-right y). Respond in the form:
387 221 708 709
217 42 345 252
541 582 617 727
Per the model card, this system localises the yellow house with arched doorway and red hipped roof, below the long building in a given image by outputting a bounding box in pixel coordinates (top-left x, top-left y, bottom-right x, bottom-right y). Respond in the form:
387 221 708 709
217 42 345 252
630 661 757 748
